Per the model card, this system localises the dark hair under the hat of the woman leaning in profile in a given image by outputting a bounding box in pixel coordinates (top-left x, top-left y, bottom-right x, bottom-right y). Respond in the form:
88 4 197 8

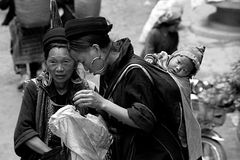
69 34 111 50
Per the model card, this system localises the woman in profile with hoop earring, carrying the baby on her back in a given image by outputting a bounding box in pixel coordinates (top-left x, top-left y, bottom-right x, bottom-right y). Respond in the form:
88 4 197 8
65 17 197 160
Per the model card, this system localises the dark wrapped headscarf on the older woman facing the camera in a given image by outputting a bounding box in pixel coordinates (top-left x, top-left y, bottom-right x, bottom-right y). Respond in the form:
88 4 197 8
43 27 68 59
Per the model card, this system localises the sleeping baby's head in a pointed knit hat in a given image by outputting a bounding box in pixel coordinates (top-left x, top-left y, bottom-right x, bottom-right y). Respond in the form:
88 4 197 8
168 46 205 77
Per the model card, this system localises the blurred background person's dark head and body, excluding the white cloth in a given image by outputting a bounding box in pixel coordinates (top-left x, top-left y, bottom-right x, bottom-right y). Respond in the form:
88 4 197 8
141 18 181 58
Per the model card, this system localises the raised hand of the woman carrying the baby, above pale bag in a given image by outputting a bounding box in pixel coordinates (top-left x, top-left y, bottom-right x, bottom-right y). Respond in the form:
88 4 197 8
73 90 107 110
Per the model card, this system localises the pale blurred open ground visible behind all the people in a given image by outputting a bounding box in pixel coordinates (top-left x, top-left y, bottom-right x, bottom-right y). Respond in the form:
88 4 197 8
0 0 240 160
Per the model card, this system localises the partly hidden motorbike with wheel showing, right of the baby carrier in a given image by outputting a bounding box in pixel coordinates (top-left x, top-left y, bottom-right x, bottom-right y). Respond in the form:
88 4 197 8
191 79 231 160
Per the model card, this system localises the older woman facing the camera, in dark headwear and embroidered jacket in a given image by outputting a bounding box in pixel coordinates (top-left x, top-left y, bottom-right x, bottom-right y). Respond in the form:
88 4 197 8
14 27 95 160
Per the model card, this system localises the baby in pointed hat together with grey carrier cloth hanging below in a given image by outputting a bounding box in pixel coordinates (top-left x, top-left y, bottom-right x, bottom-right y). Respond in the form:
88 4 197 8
144 46 205 159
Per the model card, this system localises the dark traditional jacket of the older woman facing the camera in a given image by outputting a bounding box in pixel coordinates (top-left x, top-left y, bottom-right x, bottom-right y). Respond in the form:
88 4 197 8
14 72 94 160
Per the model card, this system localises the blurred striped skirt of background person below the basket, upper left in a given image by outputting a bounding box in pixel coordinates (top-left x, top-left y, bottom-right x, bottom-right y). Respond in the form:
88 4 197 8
9 19 46 64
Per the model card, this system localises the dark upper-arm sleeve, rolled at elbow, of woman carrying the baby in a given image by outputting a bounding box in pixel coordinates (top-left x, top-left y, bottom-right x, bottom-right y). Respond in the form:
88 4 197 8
125 68 157 132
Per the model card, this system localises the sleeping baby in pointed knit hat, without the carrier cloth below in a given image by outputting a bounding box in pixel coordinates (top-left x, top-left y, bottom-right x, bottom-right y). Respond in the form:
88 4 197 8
144 46 205 78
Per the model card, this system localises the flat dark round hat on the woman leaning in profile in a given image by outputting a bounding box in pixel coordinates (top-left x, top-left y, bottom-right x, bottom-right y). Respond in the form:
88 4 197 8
65 17 112 40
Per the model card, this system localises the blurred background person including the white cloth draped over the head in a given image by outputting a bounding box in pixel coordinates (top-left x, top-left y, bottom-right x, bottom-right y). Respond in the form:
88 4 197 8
139 0 183 58
